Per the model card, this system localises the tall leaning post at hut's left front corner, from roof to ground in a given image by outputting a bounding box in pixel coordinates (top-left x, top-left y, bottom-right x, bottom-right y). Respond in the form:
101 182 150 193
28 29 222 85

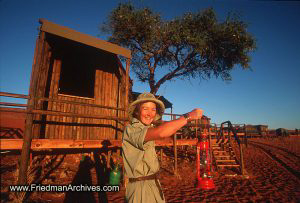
18 32 45 185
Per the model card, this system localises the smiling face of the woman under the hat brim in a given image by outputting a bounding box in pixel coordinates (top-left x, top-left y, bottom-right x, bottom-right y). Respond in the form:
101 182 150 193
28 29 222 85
139 102 156 125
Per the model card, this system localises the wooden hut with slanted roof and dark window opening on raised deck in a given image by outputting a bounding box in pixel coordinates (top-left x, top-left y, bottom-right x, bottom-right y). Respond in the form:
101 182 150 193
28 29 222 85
30 19 132 140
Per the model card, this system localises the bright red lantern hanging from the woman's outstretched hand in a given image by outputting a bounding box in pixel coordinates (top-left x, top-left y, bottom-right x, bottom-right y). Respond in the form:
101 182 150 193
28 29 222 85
197 134 215 190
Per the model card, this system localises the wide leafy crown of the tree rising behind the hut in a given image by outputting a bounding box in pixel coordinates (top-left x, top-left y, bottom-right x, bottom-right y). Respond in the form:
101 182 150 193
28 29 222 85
101 3 255 94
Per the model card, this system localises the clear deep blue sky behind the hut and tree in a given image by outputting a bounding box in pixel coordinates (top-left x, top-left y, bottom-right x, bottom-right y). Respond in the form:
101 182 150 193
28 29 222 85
0 0 300 129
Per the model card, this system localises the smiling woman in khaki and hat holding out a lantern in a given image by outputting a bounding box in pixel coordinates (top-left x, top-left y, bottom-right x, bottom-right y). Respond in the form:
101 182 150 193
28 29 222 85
122 93 202 203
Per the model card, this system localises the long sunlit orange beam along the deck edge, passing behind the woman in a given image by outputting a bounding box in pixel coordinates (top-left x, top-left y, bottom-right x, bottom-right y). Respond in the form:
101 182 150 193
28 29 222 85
0 139 197 150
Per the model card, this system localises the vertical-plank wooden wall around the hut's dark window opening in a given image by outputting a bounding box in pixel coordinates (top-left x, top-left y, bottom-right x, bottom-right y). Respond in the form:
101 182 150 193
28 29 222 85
45 56 126 140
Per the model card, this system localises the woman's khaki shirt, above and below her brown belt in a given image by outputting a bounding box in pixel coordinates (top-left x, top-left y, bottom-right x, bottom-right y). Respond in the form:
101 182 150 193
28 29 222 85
122 118 164 203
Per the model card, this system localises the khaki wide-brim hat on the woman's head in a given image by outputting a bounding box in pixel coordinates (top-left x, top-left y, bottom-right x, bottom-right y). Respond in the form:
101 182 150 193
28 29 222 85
128 92 165 121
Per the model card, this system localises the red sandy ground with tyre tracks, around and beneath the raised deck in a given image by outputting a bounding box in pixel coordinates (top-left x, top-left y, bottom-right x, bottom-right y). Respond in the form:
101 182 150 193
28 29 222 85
1 137 300 203
